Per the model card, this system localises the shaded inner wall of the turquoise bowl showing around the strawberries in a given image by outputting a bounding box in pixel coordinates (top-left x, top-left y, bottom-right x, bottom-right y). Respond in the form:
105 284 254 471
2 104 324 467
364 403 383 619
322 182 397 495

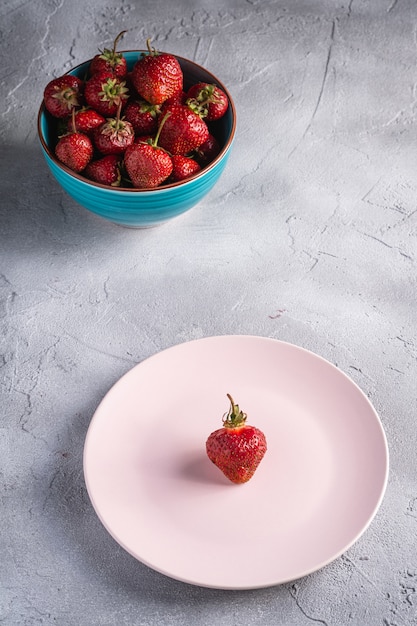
42 50 235 189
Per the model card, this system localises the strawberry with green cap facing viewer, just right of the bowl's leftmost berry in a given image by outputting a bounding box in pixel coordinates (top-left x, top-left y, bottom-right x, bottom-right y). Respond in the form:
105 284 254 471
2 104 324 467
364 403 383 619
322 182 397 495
84 71 129 117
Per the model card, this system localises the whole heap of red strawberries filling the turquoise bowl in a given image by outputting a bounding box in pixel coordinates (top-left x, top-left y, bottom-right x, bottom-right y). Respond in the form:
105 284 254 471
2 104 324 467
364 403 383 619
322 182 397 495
43 31 229 189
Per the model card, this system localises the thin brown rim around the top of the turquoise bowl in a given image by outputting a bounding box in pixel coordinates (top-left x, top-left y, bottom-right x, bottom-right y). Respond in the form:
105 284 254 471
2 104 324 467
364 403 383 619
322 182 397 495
37 49 236 193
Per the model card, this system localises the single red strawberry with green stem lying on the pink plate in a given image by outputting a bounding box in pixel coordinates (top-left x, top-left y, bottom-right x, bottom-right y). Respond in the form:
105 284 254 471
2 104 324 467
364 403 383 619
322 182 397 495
206 394 267 484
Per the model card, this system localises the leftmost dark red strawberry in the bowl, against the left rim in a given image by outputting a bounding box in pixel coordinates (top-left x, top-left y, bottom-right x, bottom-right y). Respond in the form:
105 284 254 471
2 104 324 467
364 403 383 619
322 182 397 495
43 74 84 118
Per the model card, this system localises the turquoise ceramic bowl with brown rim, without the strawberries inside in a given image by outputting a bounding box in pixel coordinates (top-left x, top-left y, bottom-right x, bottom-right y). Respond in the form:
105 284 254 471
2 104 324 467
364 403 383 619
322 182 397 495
38 50 236 228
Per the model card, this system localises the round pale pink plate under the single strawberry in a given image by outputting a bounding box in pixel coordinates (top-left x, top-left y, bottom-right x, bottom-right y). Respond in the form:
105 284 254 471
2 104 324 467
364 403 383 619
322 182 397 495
84 335 388 589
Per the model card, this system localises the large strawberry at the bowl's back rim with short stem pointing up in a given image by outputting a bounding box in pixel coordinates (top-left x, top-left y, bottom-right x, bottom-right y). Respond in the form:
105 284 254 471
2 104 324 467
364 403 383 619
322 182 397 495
132 39 183 104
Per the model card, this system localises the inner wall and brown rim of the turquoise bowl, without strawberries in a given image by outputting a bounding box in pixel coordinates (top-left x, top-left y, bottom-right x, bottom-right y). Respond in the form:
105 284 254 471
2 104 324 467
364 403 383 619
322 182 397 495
38 50 236 192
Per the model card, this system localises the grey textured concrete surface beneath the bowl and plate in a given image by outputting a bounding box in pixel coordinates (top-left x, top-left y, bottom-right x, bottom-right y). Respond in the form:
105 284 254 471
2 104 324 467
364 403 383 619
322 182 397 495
0 0 417 626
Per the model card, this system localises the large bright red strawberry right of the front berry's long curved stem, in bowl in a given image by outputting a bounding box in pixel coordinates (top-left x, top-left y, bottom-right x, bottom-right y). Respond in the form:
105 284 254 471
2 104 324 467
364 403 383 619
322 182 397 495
159 104 209 155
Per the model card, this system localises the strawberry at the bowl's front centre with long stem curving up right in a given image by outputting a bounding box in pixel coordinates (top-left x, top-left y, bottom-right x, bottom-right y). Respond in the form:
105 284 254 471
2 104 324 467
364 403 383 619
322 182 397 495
124 112 173 189
